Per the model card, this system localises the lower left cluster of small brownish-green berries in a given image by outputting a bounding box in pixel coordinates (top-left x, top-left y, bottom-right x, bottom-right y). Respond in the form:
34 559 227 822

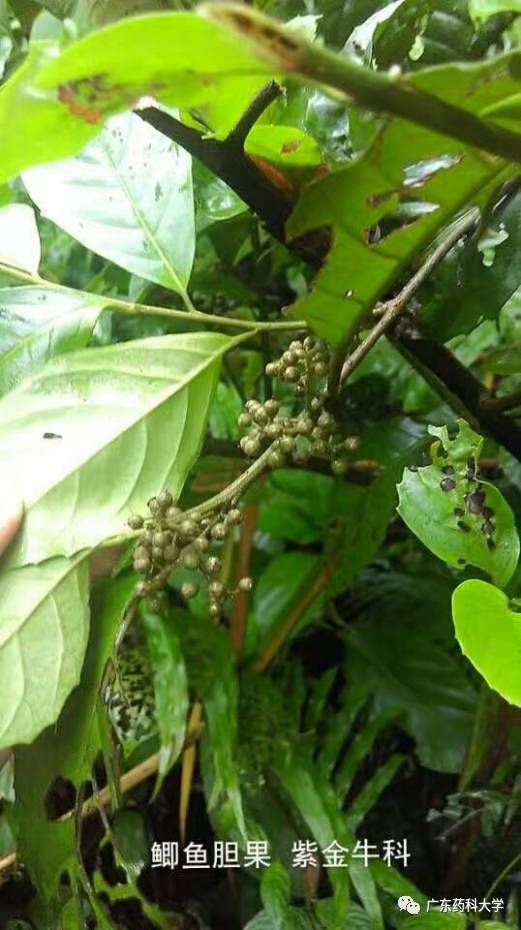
128 491 252 619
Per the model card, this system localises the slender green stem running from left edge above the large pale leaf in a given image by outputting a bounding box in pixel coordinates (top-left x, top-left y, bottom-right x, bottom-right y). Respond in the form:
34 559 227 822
0 264 307 335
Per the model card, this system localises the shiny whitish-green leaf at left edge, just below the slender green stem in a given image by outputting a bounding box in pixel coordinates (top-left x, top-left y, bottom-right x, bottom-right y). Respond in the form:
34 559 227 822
0 286 103 395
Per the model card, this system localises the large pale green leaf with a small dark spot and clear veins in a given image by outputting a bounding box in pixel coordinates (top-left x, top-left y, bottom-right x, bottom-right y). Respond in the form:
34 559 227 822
0 333 240 565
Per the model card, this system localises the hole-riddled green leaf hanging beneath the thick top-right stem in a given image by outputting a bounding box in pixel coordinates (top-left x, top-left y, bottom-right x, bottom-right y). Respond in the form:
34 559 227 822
287 120 498 344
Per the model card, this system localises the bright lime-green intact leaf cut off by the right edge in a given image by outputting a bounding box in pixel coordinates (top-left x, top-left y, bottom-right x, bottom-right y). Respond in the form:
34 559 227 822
452 579 521 706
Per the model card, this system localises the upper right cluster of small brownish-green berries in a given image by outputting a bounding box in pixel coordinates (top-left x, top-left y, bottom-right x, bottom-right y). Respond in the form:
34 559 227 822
238 336 359 475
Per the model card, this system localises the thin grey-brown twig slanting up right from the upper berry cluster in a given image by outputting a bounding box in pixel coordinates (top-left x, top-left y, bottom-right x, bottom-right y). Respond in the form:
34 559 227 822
340 210 479 384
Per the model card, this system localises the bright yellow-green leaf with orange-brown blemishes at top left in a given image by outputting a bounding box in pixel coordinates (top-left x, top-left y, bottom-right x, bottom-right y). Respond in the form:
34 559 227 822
0 13 272 182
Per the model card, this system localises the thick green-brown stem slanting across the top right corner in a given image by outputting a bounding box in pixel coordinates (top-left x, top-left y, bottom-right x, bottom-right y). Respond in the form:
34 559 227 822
205 3 521 162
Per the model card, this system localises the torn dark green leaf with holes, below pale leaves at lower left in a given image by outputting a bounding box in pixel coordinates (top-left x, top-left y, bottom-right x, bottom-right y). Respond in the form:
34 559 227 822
12 572 135 912
